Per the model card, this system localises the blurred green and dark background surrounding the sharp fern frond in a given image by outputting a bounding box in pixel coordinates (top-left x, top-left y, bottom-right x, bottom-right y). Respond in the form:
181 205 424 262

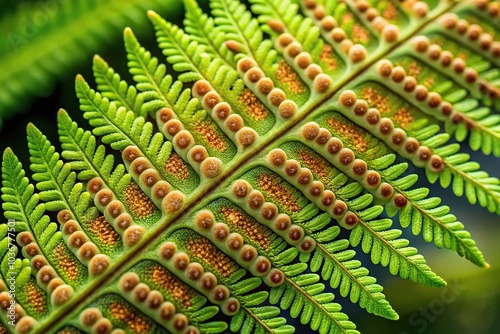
0 0 500 334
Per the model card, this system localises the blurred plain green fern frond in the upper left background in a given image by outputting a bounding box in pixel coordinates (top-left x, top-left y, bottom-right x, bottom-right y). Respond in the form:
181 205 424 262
0 0 184 127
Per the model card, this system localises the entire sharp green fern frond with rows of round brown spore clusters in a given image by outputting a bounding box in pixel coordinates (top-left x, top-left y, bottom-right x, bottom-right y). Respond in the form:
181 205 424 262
0 0 500 334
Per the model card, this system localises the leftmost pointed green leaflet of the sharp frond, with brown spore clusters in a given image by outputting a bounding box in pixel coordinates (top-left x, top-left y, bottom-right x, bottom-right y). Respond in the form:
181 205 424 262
0 149 80 323
